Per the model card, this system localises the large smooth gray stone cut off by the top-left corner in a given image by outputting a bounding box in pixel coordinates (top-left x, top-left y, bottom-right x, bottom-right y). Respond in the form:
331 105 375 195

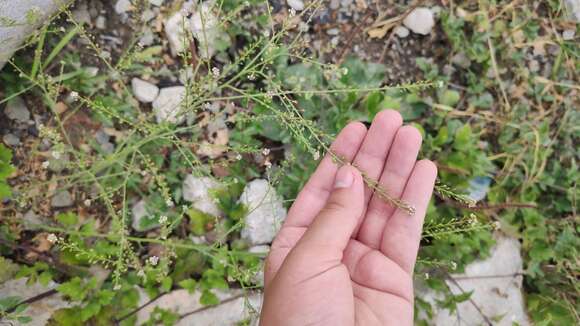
0 0 71 69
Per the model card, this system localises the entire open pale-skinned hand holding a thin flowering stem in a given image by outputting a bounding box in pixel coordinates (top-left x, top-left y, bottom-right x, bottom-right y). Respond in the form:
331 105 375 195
260 110 437 326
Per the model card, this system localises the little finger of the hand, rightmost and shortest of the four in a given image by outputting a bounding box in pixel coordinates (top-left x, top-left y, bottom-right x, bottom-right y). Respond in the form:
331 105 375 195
381 160 437 273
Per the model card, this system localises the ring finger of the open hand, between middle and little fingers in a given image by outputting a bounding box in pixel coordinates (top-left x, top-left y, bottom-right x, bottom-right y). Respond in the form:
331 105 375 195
357 126 421 249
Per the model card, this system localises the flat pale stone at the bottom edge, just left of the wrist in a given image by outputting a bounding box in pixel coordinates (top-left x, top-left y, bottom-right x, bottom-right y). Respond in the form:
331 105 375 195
137 289 262 326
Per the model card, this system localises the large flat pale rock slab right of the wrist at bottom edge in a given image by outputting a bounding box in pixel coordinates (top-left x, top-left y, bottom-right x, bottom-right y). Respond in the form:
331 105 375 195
416 234 530 326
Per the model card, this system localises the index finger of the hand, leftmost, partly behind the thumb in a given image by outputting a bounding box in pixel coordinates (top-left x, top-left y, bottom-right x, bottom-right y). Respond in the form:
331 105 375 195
283 122 367 227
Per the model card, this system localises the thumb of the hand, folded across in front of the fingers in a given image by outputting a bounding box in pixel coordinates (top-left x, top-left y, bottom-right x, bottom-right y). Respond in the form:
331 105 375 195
297 165 364 253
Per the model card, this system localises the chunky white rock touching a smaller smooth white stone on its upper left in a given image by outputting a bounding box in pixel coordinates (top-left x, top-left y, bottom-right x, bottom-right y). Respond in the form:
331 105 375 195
153 86 185 124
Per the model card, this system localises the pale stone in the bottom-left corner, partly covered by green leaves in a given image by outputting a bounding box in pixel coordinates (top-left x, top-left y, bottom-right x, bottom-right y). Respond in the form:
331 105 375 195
0 278 72 326
